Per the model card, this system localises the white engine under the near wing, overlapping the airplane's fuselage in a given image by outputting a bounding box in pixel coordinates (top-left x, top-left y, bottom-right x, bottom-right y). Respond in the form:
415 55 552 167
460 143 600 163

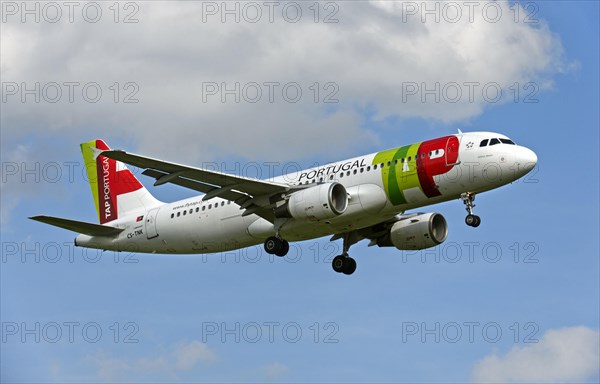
287 183 348 220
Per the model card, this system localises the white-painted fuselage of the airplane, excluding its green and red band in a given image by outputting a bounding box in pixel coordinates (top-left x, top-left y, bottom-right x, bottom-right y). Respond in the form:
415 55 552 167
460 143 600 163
75 132 536 254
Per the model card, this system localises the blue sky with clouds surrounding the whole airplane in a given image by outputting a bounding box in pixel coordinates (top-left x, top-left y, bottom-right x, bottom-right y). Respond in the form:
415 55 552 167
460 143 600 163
0 1 600 383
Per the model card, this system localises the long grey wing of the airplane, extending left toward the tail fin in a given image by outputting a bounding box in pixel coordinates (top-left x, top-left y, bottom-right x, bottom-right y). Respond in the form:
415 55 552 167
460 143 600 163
101 150 293 222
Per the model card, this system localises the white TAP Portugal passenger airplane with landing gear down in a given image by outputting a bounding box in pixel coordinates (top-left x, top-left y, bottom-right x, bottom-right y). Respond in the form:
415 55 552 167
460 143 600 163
30 130 537 275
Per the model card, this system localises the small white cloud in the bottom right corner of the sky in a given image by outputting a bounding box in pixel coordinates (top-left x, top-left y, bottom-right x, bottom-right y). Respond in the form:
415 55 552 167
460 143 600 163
472 326 600 383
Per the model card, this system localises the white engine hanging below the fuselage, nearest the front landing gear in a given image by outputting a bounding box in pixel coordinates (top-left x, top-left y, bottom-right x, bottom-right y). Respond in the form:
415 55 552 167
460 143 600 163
390 213 448 251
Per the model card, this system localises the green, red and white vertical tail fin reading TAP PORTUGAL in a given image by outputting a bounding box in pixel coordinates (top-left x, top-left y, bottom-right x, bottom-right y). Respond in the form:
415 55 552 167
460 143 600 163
81 140 161 224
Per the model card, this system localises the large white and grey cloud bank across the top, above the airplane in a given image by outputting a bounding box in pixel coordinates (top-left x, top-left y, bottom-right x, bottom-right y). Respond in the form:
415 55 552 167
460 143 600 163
0 1 563 163
